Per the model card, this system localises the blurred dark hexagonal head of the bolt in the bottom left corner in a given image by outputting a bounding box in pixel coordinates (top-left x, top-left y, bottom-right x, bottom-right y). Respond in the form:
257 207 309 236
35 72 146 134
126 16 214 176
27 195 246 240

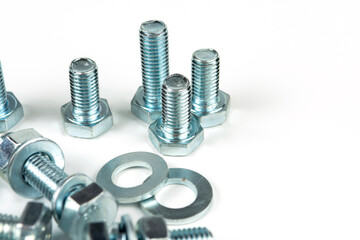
17 202 52 240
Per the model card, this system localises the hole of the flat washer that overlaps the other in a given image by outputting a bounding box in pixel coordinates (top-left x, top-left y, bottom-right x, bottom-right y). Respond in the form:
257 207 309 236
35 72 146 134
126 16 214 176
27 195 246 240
112 166 152 188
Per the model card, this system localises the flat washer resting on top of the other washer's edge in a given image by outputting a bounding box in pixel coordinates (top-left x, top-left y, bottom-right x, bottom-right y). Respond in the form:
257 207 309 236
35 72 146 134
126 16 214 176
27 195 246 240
96 152 168 203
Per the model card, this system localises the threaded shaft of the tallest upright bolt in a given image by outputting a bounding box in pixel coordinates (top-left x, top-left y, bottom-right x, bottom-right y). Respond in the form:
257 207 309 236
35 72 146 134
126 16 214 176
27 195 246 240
140 21 169 109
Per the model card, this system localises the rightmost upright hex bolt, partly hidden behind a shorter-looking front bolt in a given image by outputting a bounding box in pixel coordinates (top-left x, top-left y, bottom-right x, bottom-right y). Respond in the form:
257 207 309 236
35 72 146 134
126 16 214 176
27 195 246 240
191 48 230 127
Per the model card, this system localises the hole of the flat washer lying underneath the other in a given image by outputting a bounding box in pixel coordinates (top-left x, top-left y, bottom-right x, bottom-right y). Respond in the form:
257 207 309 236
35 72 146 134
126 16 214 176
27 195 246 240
155 184 196 209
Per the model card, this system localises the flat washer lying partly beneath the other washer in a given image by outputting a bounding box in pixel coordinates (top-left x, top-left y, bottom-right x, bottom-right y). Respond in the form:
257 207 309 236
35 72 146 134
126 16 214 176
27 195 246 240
140 168 213 225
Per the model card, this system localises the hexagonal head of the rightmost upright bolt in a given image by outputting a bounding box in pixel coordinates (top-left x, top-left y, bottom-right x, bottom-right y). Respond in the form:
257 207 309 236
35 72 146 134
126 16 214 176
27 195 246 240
192 91 230 128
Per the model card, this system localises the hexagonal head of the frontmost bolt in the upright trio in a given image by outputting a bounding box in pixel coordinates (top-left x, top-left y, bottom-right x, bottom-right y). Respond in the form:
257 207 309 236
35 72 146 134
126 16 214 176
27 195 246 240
149 116 204 156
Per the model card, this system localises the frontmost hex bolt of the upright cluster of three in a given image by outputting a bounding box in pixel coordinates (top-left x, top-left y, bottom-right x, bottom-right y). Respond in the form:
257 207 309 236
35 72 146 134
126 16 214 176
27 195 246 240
149 74 204 156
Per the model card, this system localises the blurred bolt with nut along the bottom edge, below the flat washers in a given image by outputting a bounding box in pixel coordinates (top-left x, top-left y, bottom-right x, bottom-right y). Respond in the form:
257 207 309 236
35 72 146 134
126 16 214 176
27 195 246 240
86 215 213 240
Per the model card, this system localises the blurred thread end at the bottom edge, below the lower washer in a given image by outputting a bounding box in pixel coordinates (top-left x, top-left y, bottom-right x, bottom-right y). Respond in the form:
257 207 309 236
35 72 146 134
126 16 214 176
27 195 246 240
170 228 213 240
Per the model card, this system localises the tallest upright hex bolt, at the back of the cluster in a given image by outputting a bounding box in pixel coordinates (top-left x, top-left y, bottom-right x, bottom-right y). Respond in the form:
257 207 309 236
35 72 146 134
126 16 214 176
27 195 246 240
131 20 169 123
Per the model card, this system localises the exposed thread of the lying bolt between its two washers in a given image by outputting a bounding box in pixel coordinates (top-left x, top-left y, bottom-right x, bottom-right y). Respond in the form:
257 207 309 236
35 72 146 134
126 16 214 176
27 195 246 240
23 153 67 201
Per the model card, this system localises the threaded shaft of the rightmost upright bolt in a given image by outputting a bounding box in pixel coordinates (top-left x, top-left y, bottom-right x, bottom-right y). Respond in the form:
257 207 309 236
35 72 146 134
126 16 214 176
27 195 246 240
191 49 220 112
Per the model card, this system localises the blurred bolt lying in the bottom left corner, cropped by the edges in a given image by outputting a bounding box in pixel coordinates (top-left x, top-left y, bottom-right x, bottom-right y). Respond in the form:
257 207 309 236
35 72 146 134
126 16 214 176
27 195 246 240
0 202 52 240
